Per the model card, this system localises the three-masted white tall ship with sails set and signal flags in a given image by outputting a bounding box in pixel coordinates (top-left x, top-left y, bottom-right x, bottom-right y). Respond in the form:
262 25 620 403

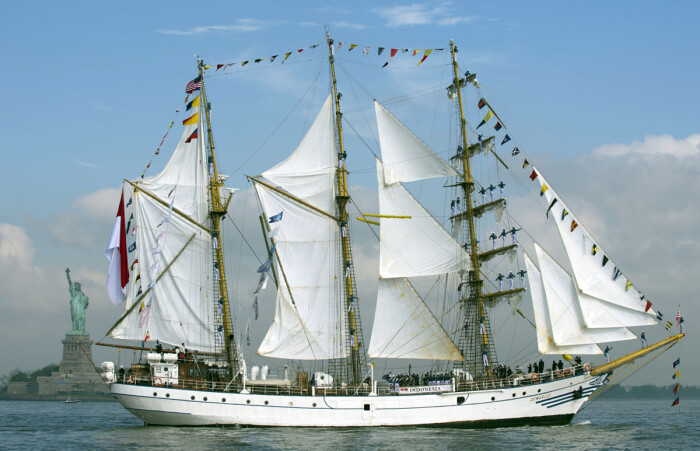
99 35 683 427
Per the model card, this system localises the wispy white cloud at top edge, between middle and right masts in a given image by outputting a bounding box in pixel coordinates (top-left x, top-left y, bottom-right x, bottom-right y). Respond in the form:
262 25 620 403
372 3 478 27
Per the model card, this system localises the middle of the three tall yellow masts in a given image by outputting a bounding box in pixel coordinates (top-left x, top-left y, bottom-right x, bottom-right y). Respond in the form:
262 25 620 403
326 30 364 383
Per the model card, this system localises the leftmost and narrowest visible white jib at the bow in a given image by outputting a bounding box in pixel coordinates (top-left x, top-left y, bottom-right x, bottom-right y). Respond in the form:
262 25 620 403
523 254 603 355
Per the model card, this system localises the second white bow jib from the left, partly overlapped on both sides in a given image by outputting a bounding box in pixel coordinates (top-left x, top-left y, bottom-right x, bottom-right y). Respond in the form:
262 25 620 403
535 243 636 346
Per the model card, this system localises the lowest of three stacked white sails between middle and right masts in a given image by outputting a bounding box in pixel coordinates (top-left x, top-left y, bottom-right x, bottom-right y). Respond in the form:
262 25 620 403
367 278 464 361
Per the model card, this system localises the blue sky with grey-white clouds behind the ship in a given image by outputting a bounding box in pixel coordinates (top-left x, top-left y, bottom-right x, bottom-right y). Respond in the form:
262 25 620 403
0 0 700 385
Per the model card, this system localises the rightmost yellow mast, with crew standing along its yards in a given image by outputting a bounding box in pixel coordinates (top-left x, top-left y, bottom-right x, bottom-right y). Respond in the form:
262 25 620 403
450 40 497 378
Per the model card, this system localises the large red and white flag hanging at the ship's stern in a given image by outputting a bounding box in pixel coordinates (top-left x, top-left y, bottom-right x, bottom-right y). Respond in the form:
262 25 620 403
105 192 129 305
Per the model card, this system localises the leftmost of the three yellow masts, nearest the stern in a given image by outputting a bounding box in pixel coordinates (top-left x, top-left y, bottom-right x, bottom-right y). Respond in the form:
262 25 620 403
197 59 238 374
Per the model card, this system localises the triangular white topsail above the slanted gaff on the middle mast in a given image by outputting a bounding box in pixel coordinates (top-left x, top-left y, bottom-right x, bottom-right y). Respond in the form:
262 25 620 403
262 96 338 209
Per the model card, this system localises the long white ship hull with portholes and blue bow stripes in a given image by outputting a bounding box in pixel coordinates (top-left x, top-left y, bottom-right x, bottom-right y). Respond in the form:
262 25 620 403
111 374 606 427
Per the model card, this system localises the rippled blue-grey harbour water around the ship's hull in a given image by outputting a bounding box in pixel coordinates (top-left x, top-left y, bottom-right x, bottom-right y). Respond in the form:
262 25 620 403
0 399 700 451
